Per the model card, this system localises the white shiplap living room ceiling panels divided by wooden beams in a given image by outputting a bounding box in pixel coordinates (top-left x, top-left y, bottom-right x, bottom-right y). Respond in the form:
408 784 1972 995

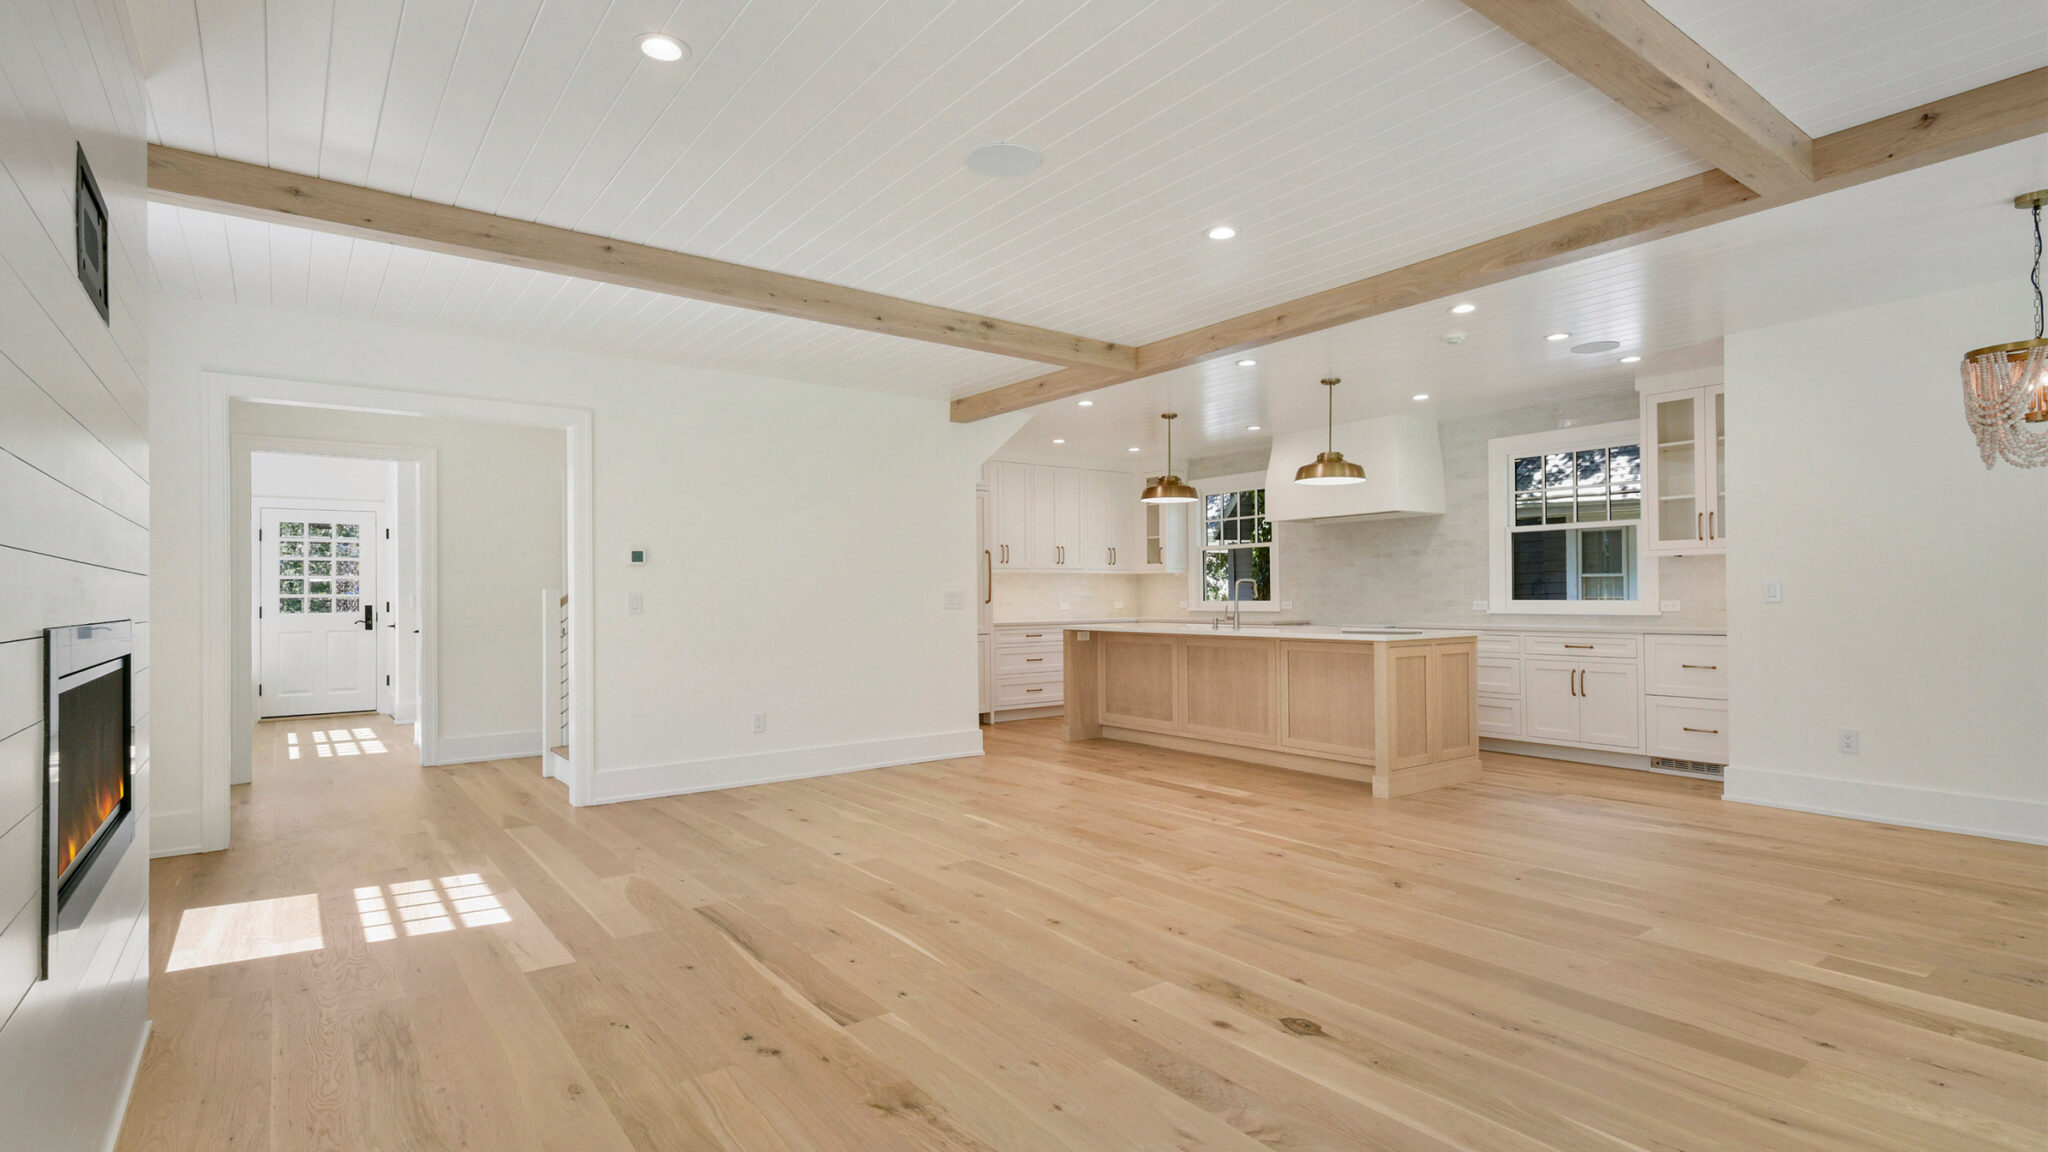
129 0 2048 396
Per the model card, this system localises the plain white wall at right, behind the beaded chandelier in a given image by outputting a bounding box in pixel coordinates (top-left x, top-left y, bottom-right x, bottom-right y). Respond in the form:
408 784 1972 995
1726 273 2048 840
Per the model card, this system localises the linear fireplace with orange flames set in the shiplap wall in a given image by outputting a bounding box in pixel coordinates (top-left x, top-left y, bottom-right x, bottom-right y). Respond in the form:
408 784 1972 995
43 619 135 980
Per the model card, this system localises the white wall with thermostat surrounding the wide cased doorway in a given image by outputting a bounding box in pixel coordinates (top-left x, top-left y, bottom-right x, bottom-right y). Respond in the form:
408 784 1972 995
150 297 1022 847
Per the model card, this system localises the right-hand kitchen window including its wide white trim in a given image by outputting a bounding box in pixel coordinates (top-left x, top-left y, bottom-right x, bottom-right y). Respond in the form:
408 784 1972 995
1487 420 1657 615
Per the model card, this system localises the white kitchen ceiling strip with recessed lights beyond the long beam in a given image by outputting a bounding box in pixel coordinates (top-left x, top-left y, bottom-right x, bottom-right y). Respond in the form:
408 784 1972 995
1024 137 2048 469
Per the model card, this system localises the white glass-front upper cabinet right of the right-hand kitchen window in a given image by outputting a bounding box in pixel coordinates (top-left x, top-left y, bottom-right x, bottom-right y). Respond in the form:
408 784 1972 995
1642 383 1729 556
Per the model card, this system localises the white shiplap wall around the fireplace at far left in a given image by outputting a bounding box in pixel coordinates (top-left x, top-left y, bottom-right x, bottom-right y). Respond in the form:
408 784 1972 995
0 0 150 1152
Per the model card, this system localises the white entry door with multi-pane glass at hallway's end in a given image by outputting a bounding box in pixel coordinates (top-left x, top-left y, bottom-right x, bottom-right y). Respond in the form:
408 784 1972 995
256 508 383 715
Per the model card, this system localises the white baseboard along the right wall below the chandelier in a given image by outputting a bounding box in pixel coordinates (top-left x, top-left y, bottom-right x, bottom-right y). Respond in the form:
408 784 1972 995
1722 765 2048 845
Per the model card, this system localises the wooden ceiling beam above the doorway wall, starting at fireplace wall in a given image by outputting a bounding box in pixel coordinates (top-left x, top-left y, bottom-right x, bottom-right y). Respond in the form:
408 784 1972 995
150 143 1137 371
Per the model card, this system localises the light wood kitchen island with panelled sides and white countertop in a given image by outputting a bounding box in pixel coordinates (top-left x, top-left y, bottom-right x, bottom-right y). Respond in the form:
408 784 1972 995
1065 623 1479 797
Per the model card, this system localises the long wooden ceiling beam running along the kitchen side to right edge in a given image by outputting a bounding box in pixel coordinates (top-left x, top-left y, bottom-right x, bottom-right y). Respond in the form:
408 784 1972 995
952 68 2048 422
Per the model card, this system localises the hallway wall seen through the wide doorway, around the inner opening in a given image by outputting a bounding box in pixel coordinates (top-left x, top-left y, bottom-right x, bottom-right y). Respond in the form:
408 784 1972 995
229 404 567 763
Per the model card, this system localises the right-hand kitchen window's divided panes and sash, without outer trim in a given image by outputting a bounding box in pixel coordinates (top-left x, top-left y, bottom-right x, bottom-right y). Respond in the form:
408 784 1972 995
1507 443 1642 601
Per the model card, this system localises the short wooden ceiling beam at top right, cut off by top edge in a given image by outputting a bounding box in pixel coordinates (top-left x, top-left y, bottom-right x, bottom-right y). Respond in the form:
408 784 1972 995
1464 0 1812 195
